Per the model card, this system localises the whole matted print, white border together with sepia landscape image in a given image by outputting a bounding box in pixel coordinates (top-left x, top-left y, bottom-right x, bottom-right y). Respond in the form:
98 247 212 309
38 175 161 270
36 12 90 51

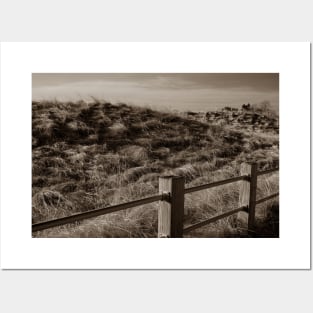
0 42 311 270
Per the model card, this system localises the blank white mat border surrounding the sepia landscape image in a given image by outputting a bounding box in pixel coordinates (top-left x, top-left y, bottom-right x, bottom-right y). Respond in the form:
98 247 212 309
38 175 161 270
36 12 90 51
1 43 310 269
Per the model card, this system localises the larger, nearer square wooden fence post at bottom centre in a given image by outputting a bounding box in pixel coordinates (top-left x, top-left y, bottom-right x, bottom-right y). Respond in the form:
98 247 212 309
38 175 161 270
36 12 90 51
158 176 185 238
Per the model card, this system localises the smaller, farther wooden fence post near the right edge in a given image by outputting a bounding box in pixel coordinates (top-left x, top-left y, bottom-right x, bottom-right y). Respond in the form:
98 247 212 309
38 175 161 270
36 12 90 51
239 163 257 236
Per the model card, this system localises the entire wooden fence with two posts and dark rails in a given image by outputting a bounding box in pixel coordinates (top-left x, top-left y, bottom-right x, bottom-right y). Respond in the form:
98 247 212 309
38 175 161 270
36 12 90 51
32 163 279 238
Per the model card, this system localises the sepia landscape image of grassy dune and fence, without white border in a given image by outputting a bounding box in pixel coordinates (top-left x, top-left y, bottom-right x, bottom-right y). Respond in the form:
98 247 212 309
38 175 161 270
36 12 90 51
32 73 279 238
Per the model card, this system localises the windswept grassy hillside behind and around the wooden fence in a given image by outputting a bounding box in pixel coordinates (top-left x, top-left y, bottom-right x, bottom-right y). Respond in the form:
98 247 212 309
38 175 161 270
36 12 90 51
32 101 278 237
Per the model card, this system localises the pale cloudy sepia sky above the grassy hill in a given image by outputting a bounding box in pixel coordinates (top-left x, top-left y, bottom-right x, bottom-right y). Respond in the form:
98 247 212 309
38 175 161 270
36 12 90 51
33 73 279 111
